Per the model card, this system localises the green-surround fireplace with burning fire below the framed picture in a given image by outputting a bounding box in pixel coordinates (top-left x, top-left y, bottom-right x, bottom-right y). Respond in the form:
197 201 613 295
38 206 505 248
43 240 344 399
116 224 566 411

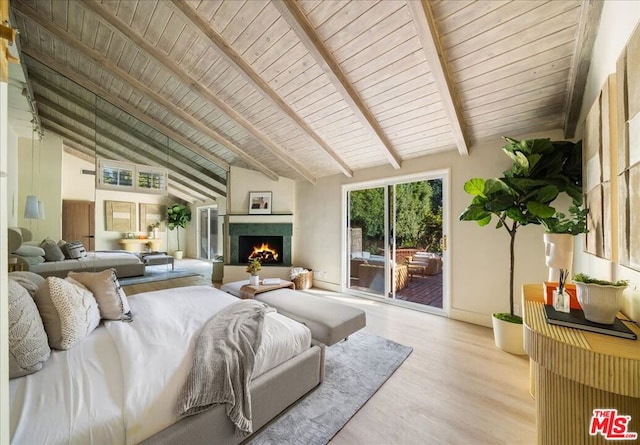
229 222 293 267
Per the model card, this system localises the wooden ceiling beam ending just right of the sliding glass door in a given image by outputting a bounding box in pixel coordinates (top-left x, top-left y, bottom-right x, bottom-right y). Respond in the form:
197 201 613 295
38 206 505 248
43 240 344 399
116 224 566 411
407 0 469 156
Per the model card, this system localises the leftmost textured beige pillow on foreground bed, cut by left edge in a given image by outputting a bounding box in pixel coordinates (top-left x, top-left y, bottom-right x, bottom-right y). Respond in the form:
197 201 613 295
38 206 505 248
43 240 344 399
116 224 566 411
8 279 51 379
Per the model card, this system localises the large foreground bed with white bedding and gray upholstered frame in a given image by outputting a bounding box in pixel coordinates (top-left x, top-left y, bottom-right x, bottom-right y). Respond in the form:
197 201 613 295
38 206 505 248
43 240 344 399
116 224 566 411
10 286 324 444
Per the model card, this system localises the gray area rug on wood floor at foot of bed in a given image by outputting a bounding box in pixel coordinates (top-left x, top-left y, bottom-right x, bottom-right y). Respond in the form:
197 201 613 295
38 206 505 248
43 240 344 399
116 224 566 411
245 331 413 445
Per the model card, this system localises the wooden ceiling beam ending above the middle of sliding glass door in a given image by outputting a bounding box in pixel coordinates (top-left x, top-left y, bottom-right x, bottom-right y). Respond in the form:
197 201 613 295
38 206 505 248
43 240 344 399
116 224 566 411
271 0 402 169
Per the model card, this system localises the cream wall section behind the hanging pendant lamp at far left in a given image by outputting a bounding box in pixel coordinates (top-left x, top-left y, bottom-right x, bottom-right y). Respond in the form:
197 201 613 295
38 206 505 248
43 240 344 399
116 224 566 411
18 132 62 241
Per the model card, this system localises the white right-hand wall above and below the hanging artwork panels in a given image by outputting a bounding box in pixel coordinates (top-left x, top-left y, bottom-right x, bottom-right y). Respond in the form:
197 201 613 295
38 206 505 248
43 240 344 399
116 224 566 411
574 0 640 320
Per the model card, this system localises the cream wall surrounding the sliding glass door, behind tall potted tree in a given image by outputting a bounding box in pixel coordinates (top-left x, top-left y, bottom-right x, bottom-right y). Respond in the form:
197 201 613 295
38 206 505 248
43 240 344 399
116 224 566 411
295 131 563 326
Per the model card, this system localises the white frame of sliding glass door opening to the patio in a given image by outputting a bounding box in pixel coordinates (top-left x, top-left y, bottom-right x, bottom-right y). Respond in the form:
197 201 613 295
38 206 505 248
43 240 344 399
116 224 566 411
340 168 451 317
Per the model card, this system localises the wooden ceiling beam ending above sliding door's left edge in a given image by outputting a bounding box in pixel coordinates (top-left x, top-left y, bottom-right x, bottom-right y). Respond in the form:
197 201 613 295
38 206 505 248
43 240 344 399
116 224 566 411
172 0 353 178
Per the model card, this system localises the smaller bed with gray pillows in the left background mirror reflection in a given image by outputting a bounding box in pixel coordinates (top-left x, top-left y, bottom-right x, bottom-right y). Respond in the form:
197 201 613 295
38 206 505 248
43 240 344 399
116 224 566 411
8 227 145 278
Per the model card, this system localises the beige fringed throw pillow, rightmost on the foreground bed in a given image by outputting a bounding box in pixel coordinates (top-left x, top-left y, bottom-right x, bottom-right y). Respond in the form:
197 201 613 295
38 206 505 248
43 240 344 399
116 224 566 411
68 269 133 321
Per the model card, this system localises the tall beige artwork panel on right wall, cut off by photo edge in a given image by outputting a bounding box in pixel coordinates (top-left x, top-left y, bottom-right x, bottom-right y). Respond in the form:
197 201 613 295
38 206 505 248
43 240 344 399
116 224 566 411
616 28 640 271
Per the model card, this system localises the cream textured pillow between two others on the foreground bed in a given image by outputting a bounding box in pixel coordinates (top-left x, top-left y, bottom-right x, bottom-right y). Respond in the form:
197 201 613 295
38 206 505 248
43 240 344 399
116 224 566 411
35 277 100 350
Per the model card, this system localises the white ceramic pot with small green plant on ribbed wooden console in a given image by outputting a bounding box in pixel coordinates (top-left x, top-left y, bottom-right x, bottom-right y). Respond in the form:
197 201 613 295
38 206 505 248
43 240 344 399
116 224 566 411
575 282 625 324
